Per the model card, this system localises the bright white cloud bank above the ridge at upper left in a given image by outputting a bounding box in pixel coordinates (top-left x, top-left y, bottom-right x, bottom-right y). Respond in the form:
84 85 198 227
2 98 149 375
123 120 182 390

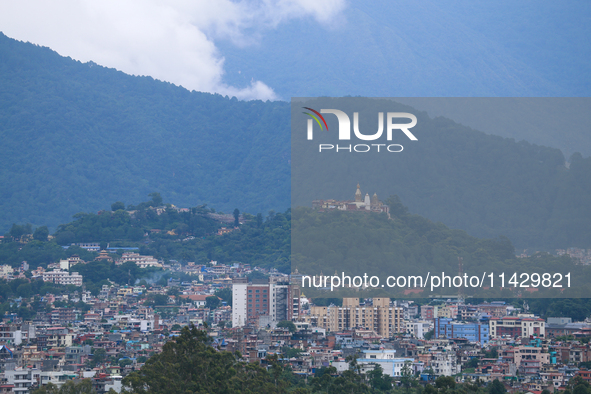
0 0 346 100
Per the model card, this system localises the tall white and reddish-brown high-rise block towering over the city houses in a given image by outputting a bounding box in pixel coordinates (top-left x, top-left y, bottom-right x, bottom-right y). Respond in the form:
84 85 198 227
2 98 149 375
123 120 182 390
232 277 300 327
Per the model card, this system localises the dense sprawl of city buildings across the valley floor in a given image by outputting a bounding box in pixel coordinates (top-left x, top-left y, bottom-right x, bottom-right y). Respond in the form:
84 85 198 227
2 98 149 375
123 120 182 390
0 249 591 393
